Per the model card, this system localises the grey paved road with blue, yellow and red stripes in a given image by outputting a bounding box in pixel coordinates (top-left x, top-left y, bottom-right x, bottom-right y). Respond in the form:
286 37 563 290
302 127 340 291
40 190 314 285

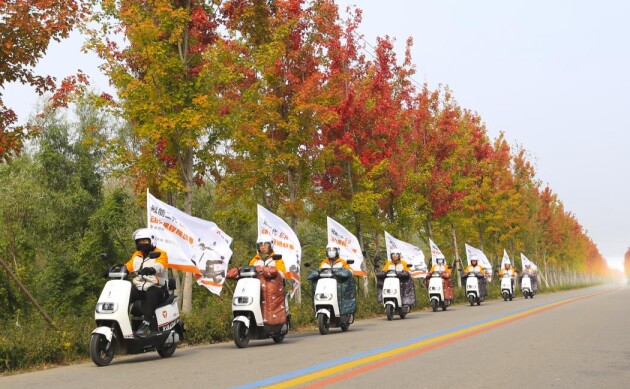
0 286 630 389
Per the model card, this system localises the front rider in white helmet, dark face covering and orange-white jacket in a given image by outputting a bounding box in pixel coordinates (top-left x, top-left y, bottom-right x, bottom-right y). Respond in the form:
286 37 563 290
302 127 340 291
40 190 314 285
125 228 168 336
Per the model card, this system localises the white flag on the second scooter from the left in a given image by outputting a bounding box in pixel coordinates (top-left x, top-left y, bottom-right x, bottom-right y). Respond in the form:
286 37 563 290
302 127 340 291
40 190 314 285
258 204 302 297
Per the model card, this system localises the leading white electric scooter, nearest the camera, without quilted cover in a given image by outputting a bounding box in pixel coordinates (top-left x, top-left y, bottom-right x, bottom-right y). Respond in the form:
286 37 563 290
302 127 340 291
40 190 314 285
90 254 184 366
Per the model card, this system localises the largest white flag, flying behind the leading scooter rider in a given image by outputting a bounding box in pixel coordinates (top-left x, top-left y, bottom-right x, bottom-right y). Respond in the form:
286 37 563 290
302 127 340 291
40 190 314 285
147 191 232 294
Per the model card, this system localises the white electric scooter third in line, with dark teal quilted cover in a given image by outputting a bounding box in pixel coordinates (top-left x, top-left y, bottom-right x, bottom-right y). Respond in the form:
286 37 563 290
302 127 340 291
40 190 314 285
313 259 354 335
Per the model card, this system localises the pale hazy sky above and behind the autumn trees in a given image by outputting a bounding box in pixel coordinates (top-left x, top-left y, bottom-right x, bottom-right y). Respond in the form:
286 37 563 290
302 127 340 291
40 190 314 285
4 0 630 268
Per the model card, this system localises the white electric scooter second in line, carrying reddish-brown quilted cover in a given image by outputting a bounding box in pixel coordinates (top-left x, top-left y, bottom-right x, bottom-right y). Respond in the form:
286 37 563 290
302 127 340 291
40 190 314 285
232 262 289 348
